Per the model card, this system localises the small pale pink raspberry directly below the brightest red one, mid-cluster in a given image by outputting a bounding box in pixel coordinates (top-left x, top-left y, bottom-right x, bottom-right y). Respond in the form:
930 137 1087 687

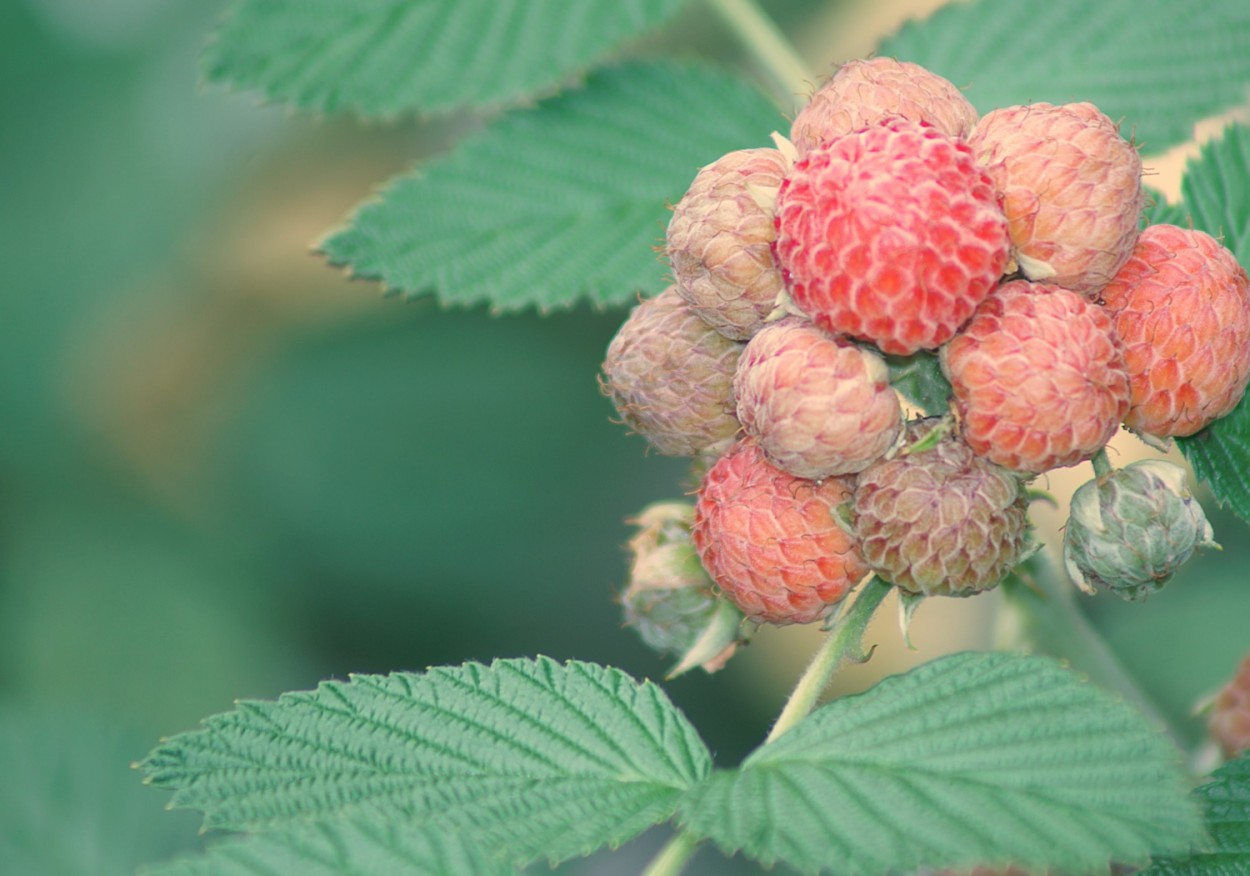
734 319 903 479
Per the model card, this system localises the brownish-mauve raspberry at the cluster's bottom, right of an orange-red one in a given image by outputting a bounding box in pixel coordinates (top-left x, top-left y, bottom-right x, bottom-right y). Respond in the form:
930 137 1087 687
854 427 1029 596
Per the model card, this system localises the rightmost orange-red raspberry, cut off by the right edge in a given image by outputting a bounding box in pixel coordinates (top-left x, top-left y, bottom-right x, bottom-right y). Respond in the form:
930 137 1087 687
1103 225 1250 437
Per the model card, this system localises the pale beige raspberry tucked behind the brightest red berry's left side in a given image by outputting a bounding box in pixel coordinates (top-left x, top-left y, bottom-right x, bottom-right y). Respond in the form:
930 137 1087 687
668 149 789 341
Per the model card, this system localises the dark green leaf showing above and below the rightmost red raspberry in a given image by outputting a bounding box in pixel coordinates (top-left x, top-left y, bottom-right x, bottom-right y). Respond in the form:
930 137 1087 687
1176 125 1250 522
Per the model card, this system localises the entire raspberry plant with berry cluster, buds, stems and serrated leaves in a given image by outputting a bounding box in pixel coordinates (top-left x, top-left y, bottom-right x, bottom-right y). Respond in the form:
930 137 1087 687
129 0 1250 876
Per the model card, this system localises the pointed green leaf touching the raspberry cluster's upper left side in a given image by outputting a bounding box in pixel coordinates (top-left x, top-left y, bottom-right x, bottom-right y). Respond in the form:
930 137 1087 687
323 62 784 310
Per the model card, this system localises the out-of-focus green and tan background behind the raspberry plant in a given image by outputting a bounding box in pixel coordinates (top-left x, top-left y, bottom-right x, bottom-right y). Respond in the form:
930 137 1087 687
0 0 1250 876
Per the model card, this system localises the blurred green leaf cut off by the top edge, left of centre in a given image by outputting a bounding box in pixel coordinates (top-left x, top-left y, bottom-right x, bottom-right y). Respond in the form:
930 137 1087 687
204 0 685 115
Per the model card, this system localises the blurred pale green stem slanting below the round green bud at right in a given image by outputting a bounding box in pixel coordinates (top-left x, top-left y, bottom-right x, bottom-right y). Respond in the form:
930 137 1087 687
999 554 1184 741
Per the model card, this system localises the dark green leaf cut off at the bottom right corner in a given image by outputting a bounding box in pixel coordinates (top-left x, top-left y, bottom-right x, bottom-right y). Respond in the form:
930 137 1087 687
1143 754 1250 876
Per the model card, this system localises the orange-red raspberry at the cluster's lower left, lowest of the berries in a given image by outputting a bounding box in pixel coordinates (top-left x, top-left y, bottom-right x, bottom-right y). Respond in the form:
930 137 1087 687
694 439 868 624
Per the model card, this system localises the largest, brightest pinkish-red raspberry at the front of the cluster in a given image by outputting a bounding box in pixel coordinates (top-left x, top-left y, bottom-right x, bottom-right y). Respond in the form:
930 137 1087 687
775 119 1008 355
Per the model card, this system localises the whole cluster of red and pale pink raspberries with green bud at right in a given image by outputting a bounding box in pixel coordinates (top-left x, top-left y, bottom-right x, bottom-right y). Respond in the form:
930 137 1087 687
603 57 1250 649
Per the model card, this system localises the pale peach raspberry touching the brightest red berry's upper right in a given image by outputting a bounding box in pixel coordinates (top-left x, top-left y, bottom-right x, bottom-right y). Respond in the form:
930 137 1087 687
969 104 1145 296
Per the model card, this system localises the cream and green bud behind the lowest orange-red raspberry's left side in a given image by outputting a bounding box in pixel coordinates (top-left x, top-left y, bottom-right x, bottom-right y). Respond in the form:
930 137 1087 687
621 502 743 677
